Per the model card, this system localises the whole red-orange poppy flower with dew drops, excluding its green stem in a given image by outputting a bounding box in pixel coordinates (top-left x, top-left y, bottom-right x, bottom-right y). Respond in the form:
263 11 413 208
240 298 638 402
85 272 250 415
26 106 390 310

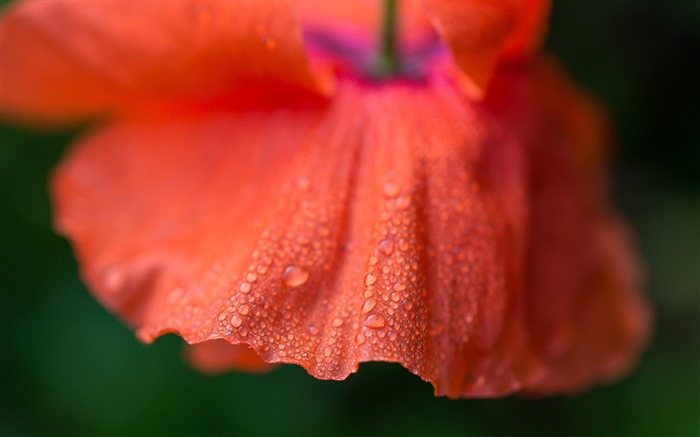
0 0 648 397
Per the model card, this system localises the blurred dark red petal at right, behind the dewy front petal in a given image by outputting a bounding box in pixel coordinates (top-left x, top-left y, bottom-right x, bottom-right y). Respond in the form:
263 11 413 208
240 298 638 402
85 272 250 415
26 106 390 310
486 59 650 393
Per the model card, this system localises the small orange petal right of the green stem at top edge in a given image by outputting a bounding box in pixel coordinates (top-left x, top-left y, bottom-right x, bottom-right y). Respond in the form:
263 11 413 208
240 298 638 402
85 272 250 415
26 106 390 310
422 0 549 98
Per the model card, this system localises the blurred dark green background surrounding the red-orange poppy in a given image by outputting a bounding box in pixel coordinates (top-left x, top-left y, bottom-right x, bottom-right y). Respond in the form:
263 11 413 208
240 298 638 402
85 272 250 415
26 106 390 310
0 0 700 436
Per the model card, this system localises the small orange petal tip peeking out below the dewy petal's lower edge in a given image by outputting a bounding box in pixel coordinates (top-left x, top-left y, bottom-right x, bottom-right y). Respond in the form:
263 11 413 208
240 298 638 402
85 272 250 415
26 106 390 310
185 340 275 374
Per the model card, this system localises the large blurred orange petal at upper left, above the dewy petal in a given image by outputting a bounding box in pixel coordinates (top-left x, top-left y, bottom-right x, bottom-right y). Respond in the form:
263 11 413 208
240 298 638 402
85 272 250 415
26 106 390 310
0 0 326 123
